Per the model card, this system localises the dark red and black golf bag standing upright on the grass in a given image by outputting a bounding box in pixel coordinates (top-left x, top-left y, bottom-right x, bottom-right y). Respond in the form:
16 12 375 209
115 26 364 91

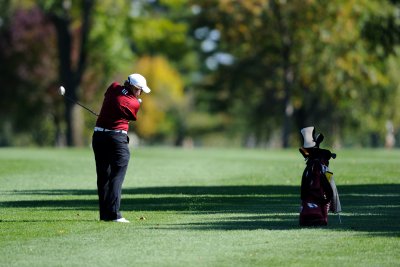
299 127 341 226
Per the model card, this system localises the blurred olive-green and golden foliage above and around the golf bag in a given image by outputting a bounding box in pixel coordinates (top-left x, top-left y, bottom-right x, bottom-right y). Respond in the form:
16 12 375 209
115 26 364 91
193 0 398 147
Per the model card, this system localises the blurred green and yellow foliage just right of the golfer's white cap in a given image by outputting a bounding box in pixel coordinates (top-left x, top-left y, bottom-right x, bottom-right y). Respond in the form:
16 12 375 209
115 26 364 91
124 0 197 145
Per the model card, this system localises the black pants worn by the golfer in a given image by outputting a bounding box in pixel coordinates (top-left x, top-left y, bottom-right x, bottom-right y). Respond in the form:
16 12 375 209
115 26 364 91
92 132 130 221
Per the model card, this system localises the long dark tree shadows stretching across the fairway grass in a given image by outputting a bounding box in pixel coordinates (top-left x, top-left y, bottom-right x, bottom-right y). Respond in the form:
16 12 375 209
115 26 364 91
0 184 400 236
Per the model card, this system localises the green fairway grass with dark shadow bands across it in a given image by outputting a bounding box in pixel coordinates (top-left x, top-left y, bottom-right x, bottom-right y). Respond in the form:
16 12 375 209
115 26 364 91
0 148 400 267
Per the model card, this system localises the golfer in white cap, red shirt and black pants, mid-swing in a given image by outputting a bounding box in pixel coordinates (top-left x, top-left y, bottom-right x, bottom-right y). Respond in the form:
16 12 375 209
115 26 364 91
92 73 150 223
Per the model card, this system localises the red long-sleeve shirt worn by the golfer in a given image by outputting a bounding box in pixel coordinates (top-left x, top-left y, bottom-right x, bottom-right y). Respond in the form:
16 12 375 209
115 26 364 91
96 82 140 131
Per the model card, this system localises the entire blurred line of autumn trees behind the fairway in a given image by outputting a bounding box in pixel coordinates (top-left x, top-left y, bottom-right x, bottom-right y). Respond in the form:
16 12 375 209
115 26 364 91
0 0 400 147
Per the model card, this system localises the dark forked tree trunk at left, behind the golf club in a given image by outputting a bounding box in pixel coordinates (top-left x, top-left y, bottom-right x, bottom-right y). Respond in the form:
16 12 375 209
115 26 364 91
39 0 94 146
